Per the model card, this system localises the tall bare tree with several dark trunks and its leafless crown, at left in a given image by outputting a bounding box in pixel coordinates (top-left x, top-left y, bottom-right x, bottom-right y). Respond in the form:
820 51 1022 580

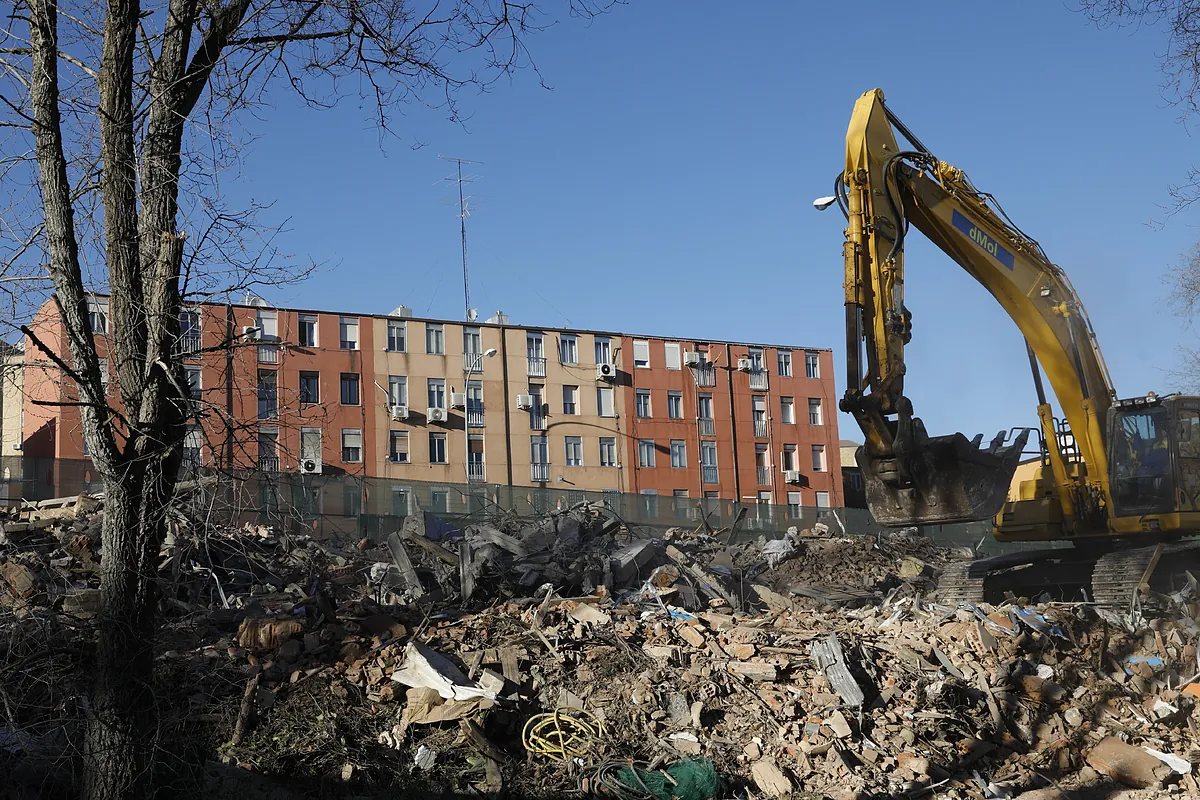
0 0 613 800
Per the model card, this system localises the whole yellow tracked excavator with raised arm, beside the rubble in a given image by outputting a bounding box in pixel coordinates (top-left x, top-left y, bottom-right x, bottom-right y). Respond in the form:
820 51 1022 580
830 89 1200 606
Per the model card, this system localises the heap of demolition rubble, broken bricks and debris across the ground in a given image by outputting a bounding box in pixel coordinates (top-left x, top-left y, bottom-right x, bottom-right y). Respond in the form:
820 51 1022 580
0 491 1200 800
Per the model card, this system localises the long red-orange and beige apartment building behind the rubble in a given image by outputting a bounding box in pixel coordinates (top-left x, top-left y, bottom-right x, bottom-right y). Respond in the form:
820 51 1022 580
22 296 841 506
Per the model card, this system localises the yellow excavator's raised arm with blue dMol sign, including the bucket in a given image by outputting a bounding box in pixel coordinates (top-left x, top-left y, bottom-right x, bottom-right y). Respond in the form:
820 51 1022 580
836 89 1115 529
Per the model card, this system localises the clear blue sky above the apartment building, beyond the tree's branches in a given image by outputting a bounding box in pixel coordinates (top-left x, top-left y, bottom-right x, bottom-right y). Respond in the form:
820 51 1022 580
218 0 1200 448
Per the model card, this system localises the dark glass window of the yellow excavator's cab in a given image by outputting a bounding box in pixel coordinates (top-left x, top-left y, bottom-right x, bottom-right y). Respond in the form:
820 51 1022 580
1110 407 1174 515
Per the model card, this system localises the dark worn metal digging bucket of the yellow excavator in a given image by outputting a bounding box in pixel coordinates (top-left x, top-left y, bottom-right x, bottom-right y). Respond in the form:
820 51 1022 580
856 431 1028 528
